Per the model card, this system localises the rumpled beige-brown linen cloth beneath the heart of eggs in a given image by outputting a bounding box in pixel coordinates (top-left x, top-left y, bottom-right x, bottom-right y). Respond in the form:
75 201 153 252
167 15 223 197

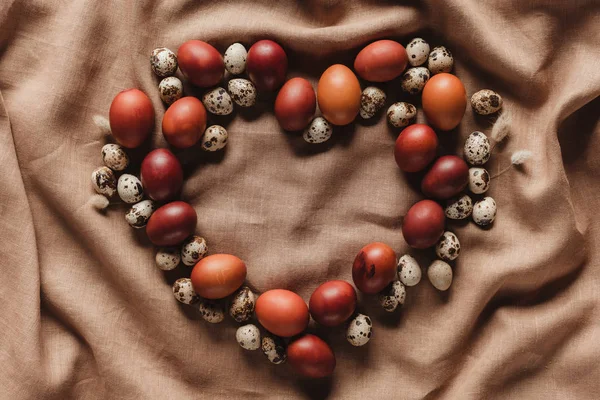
0 0 600 400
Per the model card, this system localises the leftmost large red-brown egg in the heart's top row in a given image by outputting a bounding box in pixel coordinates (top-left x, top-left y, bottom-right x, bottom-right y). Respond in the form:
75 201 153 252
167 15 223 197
177 40 225 87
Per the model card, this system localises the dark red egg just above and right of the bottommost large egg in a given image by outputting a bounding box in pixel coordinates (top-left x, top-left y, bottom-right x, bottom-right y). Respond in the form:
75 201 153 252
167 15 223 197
308 281 356 326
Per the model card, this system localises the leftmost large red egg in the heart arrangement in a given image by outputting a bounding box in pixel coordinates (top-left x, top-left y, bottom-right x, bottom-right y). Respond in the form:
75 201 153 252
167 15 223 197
108 89 154 149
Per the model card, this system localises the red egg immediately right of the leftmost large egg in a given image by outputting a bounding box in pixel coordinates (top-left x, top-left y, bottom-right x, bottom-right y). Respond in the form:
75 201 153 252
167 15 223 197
162 96 206 149
